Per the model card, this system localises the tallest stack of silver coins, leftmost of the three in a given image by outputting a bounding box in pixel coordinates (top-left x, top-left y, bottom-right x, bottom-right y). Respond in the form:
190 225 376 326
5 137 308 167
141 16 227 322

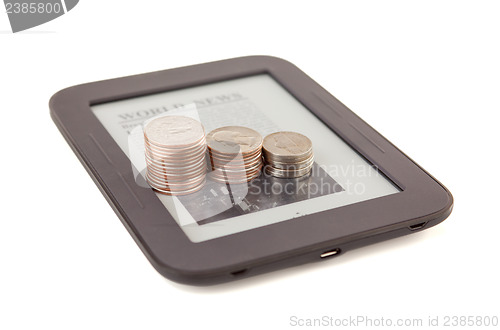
144 116 207 195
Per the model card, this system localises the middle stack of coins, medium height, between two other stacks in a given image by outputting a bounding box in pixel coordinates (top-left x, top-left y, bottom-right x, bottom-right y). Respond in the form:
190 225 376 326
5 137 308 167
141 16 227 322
207 126 262 183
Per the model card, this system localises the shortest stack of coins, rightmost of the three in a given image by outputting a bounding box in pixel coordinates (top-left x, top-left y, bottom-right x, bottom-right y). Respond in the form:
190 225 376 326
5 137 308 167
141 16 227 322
262 132 314 178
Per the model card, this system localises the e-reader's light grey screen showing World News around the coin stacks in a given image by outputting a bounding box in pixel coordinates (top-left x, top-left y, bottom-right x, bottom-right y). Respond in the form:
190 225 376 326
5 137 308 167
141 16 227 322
91 74 400 243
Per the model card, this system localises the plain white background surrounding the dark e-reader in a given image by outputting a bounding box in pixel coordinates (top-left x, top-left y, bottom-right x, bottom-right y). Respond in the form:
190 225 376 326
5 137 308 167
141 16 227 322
0 0 500 329
